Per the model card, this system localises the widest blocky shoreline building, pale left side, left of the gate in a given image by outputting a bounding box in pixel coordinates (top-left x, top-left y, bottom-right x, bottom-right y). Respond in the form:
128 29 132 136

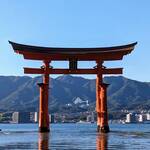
12 112 31 123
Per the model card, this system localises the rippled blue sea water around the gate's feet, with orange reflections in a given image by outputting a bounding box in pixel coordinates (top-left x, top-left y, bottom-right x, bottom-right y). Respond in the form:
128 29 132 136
0 124 150 150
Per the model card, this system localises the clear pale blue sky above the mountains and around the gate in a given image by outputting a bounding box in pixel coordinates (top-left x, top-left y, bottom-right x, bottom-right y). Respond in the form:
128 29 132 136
0 0 150 82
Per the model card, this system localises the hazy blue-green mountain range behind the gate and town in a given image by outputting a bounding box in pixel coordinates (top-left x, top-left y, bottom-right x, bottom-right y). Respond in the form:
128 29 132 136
0 75 150 112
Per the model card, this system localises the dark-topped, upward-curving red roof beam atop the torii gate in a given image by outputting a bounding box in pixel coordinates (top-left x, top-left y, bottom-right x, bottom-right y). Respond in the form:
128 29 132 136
9 41 137 61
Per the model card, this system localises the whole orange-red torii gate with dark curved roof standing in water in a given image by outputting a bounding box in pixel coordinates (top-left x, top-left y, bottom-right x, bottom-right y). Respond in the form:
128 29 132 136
9 41 137 132
